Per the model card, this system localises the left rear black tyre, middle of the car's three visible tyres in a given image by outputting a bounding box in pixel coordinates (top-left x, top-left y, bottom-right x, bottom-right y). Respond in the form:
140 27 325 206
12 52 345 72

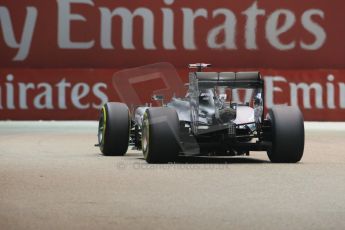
141 107 180 163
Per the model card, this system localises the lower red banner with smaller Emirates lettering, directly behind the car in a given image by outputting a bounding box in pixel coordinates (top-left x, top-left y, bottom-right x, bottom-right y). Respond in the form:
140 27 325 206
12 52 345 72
0 66 345 121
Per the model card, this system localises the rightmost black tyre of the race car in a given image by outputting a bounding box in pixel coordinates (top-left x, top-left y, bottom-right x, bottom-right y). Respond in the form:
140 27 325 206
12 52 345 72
267 106 304 163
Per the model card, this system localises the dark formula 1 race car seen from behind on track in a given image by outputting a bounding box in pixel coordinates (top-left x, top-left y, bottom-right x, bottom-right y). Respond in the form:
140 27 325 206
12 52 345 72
98 63 304 163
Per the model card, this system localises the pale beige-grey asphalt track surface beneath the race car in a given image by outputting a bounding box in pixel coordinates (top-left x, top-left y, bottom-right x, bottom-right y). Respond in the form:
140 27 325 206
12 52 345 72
0 122 345 230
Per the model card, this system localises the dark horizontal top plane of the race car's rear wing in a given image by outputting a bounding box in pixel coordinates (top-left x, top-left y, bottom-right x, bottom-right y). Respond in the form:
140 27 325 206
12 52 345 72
189 72 263 88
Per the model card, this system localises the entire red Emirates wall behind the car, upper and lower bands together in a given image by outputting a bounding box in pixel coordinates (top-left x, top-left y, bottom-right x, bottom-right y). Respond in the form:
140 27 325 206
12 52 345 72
0 0 345 121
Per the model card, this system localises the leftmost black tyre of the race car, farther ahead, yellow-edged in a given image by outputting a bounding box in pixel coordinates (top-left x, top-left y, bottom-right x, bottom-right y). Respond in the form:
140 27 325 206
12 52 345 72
98 102 131 156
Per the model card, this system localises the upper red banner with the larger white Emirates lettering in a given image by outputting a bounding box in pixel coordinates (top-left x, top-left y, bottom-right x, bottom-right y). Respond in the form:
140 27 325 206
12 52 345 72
0 0 345 68
